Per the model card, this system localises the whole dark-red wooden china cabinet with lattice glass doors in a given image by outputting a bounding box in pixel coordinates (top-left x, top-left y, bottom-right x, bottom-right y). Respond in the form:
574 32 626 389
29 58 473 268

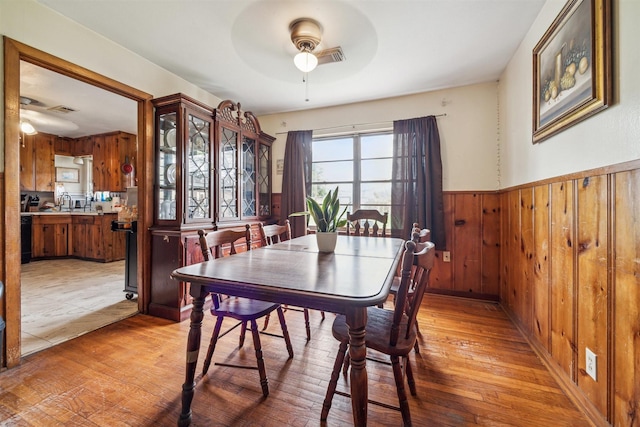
149 94 275 321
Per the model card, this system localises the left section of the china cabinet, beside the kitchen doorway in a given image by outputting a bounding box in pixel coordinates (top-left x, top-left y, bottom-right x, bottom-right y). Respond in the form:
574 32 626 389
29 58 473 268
149 94 215 320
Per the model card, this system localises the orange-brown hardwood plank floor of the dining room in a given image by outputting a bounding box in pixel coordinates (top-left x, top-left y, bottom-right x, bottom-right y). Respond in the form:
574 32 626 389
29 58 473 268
0 295 591 427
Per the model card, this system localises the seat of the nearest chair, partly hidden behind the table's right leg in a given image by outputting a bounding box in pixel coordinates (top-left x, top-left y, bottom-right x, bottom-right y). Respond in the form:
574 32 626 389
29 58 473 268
332 307 417 356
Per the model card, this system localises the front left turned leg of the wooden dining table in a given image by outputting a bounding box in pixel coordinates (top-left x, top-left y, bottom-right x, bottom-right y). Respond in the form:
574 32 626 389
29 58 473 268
178 290 206 426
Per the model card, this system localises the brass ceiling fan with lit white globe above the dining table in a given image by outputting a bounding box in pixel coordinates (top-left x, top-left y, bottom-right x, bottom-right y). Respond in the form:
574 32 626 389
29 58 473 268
289 18 346 73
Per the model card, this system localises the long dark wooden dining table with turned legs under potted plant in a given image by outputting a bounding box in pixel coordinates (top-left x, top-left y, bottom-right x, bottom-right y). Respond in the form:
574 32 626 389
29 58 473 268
171 235 404 426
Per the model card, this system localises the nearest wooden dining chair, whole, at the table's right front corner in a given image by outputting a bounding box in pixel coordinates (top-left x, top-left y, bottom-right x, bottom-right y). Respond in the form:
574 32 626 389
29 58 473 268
320 240 435 426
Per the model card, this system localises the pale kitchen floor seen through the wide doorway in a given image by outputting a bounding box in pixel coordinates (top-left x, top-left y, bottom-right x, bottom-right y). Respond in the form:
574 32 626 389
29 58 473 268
21 259 138 356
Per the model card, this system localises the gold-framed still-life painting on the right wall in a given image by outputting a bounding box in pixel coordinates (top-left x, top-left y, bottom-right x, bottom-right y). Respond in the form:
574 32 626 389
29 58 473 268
533 0 612 144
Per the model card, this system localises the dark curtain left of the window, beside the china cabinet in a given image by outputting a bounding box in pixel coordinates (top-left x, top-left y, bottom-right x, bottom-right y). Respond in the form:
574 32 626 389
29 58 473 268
280 130 313 237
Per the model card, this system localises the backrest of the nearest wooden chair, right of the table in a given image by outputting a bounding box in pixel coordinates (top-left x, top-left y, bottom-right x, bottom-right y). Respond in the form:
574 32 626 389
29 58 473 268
389 239 435 346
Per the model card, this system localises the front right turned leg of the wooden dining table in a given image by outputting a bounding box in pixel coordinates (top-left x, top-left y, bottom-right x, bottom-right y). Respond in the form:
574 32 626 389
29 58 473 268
346 307 369 427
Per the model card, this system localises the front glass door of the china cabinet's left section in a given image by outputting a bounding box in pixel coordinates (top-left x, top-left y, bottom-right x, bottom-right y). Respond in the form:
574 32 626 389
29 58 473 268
184 114 211 222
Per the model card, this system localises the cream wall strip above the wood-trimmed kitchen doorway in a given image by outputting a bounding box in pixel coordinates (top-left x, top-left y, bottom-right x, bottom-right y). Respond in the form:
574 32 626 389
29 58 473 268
0 0 221 170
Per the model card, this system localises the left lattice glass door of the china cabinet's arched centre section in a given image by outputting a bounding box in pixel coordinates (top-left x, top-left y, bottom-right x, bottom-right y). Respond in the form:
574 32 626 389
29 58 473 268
218 127 238 220
